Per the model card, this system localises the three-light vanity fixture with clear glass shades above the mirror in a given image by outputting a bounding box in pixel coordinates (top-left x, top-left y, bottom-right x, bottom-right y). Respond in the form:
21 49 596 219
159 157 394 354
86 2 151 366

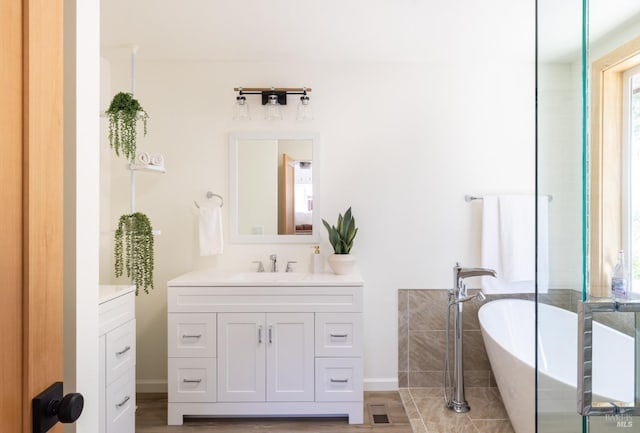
233 87 313 120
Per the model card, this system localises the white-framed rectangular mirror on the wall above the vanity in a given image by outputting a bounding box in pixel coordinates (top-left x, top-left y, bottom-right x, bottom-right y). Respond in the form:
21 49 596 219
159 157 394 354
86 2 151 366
229 133 320 243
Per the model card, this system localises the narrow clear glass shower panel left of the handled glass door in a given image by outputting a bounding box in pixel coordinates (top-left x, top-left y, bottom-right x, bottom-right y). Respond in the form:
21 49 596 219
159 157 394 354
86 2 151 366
536 0 583 433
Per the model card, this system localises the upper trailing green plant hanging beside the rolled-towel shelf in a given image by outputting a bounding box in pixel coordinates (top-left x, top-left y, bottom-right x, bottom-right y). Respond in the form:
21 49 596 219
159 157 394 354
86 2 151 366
107 92 149 161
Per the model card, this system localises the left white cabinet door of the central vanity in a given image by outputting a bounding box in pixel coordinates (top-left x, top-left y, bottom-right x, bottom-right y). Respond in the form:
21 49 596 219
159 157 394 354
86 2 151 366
218 313 267 402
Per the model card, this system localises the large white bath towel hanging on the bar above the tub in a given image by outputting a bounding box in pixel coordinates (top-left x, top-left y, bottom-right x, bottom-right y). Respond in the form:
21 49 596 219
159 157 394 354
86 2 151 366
482 195 549 293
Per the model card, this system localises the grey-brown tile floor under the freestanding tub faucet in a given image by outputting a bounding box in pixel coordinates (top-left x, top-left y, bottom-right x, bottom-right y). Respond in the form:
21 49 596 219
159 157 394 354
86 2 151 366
400 387 514 433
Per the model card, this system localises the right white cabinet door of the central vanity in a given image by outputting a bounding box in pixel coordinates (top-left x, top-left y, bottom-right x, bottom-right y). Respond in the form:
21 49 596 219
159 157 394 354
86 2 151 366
267 313 314 402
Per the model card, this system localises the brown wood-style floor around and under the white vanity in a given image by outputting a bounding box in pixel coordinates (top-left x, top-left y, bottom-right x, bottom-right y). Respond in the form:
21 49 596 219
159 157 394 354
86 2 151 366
136 392 412 433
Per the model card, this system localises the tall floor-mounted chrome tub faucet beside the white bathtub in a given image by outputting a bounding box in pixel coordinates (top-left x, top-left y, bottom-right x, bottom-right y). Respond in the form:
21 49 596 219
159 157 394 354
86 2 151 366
444 263 497 413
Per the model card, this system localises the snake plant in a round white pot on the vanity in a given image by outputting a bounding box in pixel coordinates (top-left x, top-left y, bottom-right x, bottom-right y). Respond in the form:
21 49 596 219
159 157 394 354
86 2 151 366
322 207 358 275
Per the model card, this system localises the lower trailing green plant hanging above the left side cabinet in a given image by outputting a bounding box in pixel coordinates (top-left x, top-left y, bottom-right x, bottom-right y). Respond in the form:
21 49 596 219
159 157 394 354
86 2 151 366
114 212 153 295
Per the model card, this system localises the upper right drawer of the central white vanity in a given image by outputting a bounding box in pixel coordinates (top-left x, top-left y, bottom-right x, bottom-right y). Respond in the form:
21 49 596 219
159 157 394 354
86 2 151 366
315 313 362 357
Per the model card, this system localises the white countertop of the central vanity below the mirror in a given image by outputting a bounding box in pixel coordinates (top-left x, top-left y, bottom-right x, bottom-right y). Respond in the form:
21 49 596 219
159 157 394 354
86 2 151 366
167 269 364 287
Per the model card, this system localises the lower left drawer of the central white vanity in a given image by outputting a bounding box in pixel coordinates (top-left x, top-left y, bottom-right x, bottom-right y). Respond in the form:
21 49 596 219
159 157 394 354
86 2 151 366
168 358 216 403
